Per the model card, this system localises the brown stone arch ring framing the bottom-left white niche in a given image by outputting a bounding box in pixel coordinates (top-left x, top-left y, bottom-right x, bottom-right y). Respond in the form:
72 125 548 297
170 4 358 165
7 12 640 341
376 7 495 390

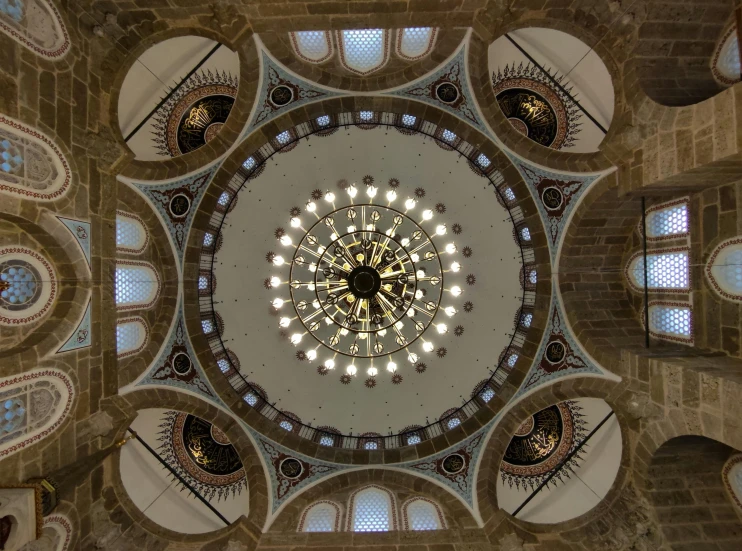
108 387 268 543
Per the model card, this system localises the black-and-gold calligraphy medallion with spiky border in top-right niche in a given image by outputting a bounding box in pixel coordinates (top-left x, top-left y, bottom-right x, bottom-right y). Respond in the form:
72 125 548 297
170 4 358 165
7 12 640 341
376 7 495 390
492 63 582 149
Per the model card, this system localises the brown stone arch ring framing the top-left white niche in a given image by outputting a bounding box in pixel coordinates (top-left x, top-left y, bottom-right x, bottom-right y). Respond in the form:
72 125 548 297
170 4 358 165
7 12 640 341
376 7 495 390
108 27 259 180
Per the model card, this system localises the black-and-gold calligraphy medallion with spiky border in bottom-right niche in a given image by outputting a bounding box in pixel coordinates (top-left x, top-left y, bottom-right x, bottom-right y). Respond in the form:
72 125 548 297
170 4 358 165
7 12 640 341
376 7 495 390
500 402 587 491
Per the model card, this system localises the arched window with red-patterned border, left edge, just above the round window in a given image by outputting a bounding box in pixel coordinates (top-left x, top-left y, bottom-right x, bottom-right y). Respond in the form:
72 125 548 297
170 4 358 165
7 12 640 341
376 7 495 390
0 115 72 201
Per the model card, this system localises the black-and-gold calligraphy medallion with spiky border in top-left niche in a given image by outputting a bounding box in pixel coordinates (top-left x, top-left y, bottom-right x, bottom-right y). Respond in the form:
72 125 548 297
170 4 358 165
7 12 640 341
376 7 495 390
153 71 239 157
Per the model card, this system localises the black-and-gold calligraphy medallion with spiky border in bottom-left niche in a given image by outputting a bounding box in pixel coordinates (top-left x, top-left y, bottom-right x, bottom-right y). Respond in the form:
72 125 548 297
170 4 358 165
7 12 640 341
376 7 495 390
158 411 247 501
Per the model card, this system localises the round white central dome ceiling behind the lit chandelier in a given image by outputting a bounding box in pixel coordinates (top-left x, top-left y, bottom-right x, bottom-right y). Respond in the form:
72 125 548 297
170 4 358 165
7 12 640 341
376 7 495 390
213 125 523 434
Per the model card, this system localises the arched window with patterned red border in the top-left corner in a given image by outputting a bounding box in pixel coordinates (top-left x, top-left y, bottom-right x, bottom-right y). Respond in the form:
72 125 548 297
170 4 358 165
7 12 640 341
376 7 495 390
0 0 70 60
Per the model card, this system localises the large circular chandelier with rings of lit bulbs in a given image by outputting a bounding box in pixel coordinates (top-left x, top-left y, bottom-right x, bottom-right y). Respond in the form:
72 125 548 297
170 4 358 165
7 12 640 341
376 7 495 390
266 185 463 388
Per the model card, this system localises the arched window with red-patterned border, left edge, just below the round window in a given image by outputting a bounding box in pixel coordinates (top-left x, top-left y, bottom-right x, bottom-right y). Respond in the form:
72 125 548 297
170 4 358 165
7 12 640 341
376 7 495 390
0 369 74 461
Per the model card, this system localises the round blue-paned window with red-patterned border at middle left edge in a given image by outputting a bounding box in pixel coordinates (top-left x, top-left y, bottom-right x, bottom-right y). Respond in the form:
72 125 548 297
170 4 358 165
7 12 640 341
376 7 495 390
0 247 57 325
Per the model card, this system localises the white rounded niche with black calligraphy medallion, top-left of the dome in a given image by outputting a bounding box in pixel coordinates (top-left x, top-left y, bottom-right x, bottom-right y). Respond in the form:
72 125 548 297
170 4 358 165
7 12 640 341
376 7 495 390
118 35 240 161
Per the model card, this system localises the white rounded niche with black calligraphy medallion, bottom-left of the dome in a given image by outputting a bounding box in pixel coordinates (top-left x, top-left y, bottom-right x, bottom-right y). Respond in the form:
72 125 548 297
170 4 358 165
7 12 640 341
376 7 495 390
119 408 249 534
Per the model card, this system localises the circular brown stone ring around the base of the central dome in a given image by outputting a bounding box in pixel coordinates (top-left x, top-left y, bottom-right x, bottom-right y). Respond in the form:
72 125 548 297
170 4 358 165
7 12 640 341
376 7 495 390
184 97 551 463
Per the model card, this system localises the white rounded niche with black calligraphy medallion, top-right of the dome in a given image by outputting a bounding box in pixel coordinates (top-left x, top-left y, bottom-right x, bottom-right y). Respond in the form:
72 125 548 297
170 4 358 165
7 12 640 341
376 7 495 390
488 27 615 153
